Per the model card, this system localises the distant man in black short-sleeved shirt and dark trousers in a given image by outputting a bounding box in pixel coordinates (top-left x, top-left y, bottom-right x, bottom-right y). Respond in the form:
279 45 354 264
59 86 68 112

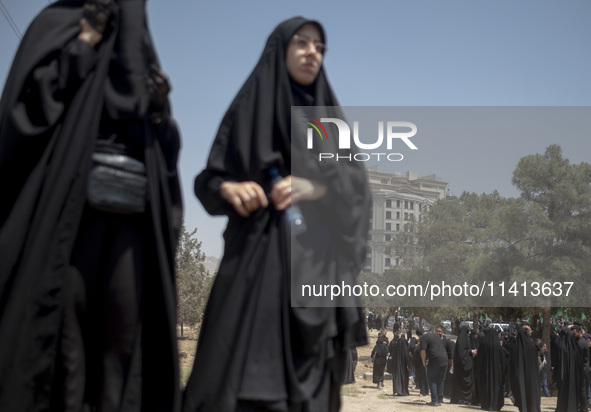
417 329 449 406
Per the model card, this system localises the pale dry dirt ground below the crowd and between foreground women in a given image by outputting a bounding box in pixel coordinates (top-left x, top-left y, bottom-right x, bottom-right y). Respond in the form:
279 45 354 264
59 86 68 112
178 328 556 412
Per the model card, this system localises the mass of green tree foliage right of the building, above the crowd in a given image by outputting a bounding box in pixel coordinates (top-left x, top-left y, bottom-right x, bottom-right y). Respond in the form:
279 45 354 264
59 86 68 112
384 145 591 307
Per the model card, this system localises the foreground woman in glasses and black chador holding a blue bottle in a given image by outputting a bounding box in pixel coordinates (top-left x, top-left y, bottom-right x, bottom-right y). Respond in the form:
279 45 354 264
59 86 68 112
184 17 372 412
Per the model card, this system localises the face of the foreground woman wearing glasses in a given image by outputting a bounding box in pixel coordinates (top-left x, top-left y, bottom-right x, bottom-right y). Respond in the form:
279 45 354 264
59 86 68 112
285 24 324 86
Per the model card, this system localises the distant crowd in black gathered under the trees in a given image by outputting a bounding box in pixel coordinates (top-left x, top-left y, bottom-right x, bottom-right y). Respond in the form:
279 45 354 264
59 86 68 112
371 320 591 412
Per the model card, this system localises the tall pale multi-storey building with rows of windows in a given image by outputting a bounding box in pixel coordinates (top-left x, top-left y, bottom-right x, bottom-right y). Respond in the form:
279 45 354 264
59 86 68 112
363 166 447 274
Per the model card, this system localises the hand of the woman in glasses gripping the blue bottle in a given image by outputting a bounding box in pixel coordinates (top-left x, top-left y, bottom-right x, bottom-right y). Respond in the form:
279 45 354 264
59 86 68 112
271 175 326 210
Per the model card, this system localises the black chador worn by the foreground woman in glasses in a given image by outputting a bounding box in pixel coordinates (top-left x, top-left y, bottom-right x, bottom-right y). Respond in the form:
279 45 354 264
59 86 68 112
185 17 370 411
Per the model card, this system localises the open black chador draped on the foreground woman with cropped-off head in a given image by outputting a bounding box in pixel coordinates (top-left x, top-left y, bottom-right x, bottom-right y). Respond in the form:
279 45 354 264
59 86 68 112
0 0 182 410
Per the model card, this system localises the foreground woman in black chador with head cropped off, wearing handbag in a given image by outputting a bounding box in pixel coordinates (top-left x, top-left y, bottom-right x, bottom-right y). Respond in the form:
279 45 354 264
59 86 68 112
0 0 182 412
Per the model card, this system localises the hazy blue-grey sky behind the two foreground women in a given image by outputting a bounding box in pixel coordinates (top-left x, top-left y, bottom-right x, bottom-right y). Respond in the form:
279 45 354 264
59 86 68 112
0 0 591 257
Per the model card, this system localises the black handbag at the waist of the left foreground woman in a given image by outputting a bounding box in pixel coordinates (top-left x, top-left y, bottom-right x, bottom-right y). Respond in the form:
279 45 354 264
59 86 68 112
86 153 148 213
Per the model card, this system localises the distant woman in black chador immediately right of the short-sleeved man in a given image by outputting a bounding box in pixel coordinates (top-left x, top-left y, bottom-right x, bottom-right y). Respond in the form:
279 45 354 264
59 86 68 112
450 325 474 405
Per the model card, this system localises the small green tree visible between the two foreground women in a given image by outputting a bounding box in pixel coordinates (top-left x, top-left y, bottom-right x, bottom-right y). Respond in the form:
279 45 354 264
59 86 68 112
176 224 211 337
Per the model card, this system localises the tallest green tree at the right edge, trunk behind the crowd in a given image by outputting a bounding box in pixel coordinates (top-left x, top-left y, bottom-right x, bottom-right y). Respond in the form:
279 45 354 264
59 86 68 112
513 145 591 342
